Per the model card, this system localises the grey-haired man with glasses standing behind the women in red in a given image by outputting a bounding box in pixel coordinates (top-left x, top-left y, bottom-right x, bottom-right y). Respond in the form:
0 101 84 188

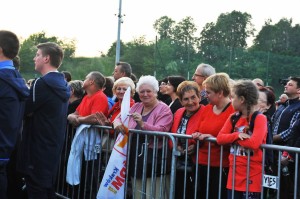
192 63 216 105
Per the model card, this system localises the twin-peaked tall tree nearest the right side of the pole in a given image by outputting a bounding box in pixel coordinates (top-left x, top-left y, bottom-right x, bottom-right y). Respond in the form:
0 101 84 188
154 16 197 78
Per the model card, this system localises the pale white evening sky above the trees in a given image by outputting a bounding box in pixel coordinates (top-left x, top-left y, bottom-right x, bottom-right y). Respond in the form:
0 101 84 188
0 0 300 57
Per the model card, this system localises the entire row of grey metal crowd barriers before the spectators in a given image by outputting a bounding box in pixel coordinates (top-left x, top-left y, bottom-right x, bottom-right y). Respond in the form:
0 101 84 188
56 126 300 199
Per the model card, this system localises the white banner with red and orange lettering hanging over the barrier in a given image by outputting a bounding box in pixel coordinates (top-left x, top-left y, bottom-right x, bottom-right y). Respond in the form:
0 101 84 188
97 87 131 199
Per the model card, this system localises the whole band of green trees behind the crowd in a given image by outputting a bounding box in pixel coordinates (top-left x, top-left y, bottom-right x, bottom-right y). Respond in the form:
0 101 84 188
20 11 300 95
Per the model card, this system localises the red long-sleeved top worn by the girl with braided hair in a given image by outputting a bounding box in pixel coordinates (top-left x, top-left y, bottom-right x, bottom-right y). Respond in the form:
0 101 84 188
217 114 267 192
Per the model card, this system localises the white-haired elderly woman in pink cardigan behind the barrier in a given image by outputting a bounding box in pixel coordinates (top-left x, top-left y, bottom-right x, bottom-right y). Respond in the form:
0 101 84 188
114 75 173 198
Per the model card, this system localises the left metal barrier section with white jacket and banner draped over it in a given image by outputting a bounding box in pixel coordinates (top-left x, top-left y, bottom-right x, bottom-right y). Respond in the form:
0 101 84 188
56 126 177 199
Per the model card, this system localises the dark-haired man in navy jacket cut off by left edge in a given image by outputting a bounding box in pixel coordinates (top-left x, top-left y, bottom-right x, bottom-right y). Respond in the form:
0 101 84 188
0 30 29 199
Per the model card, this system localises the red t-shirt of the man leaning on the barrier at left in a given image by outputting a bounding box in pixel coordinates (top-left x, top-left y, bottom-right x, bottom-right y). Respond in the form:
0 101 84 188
76 90 108 117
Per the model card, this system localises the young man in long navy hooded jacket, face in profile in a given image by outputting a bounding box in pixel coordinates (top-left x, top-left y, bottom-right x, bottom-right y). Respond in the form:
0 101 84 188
17 42 70 199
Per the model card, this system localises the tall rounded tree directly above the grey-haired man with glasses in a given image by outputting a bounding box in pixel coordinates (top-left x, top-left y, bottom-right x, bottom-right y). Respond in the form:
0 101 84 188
198 11 255 70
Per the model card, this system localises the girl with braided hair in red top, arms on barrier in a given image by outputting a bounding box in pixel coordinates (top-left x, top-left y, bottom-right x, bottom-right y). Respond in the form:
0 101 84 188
217 80 267 199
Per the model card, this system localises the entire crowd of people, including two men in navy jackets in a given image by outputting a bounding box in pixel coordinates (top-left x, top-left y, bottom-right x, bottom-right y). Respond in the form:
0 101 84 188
0 30 300 199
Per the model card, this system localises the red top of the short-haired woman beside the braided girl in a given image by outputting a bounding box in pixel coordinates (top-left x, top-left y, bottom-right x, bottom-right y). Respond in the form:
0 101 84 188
198 104 234 167
